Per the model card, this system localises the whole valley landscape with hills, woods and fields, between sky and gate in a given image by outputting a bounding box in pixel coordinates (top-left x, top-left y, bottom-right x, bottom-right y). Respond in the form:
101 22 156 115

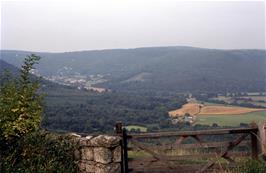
0 46 266 133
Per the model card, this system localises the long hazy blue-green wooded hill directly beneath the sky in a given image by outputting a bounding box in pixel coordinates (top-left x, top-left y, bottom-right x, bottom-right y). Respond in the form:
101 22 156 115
1 47 266 92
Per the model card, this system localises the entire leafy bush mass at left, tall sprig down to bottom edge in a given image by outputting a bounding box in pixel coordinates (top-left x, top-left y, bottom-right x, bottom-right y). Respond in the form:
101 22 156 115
0 55 75 173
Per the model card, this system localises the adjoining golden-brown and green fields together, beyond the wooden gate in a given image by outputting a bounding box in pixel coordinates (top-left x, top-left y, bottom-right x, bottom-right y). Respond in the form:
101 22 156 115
169 103 266 126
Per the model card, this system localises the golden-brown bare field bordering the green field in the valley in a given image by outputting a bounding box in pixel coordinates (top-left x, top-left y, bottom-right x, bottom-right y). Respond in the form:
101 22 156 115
168 103 266 117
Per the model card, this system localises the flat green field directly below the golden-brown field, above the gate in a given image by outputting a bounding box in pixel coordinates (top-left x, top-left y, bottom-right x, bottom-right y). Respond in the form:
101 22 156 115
195 111 266 126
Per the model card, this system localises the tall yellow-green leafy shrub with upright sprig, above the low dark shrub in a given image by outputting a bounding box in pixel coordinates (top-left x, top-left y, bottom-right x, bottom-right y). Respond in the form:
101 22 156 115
0 55 43 141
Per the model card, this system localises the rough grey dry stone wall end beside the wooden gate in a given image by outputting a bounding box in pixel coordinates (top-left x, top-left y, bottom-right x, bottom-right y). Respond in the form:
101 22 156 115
74 135 121 173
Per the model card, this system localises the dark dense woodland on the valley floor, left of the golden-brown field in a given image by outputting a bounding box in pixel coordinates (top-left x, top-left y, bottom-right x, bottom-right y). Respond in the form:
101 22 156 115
0 61 185 133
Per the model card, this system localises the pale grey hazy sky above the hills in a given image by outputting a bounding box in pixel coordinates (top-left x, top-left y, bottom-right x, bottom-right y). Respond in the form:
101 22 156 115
1 0 265 52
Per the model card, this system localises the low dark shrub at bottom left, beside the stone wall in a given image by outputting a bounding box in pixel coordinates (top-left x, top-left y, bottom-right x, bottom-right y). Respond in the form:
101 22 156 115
0 131 76 173
